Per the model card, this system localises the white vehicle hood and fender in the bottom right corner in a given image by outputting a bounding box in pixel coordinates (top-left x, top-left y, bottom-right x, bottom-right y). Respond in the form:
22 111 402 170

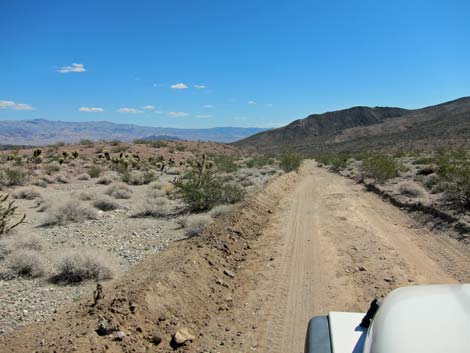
305 284 470 353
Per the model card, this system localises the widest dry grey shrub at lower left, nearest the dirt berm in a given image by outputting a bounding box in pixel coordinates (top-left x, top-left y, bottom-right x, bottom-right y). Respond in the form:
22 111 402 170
51 249 115 284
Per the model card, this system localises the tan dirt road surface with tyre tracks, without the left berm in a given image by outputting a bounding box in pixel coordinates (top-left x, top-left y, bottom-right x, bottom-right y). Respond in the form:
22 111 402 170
249 162 470 353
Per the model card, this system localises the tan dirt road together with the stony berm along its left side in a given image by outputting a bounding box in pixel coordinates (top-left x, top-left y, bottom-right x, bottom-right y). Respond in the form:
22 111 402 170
0 161 470 353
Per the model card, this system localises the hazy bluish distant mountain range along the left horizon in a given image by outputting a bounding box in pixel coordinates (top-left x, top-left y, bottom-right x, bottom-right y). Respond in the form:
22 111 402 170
0 119 266 145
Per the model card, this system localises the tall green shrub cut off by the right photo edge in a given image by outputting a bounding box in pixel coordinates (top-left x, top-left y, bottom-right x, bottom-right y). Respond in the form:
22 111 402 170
436 151 470 207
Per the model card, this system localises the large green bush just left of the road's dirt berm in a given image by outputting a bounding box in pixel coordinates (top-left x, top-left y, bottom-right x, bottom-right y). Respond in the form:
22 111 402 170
174 160 243 212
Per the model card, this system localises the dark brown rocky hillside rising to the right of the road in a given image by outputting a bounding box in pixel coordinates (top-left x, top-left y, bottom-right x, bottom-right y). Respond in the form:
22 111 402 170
234 97 470 153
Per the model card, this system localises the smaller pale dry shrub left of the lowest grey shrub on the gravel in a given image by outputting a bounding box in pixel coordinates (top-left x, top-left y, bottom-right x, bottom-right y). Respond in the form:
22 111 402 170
7 249 46 278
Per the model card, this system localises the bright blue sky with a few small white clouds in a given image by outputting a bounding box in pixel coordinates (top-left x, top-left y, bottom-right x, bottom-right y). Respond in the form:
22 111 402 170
0 0 470 127
